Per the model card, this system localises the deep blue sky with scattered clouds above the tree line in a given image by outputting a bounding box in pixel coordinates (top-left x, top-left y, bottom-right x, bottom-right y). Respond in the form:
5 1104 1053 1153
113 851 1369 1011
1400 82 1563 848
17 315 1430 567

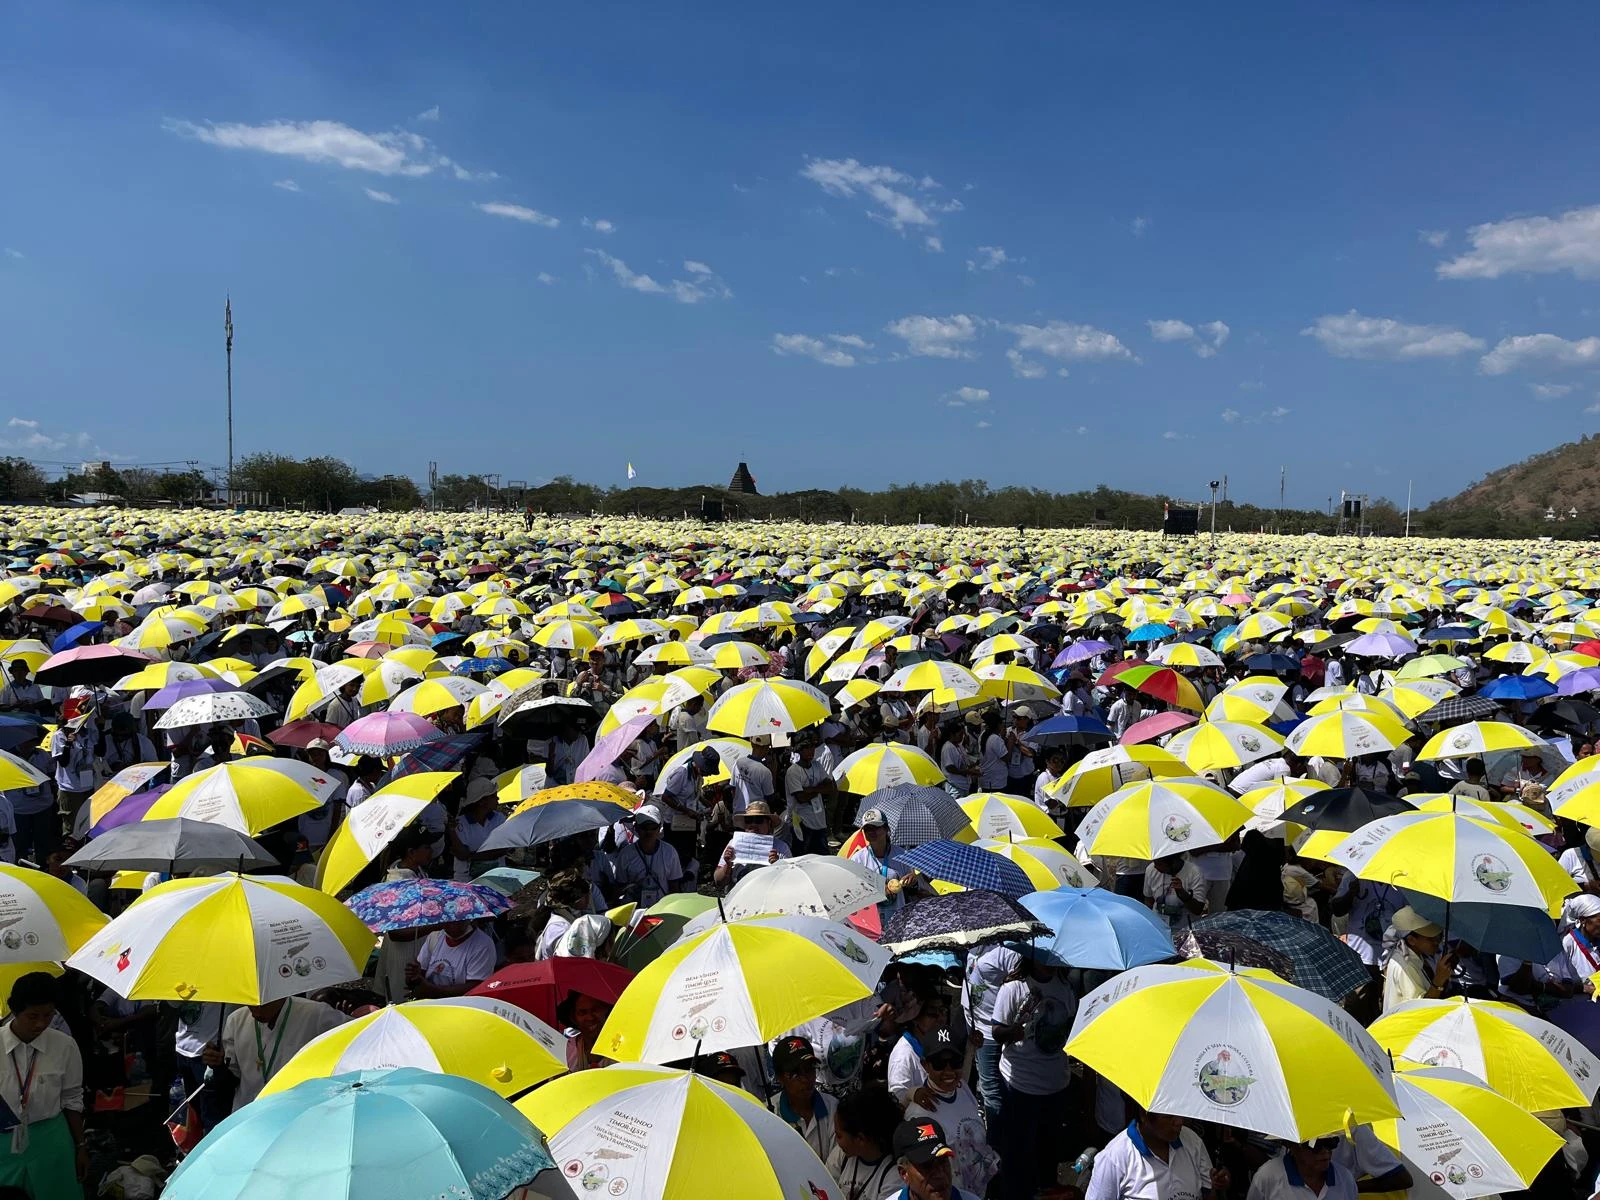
0 0 1600 507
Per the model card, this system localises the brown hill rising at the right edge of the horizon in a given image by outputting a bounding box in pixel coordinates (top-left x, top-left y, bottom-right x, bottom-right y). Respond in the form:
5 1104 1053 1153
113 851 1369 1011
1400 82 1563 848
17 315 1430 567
1422 434 1600 538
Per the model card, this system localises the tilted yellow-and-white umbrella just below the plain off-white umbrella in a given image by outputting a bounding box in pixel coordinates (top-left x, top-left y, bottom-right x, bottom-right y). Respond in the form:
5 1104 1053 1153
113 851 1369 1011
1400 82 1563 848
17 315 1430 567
595 917 890 1062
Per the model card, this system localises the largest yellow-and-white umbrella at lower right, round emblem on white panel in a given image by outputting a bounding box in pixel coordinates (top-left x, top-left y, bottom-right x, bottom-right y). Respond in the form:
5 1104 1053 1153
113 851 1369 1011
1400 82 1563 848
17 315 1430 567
1067 958 1400 1142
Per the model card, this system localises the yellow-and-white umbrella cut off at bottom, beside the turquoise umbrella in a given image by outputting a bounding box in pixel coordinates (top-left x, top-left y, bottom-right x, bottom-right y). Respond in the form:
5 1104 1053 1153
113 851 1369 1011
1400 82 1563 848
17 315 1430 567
517 1062 840 1200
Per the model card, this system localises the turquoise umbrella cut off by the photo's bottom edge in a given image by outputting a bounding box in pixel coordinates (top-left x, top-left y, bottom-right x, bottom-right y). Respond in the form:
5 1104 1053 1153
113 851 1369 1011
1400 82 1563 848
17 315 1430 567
162 1067 560 1200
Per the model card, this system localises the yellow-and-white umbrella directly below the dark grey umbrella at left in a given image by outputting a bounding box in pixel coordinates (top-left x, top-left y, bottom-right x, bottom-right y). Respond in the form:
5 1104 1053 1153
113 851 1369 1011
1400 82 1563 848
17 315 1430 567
67 874 376 1005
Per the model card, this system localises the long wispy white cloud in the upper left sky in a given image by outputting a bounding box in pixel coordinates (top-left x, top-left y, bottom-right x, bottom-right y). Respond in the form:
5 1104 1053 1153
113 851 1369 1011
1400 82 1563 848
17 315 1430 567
163 120 493 179
